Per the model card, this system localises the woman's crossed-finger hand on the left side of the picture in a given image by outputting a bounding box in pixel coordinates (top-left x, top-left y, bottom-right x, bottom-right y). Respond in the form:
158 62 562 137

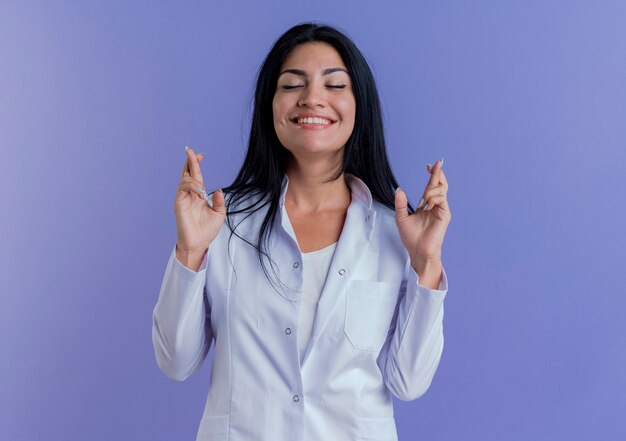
174 148 226 256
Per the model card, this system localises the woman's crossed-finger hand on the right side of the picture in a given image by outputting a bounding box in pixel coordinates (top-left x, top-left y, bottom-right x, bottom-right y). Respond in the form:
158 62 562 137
395 160 452 266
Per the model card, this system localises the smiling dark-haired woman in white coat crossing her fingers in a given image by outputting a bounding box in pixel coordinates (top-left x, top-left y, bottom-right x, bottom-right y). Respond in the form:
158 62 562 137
152 23 451 441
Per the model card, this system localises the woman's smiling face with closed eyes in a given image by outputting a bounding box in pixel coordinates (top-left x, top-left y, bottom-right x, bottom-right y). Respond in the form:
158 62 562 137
272 42 356 163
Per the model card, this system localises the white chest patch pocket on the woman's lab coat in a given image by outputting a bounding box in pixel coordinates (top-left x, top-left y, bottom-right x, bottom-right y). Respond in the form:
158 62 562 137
344 280 396 352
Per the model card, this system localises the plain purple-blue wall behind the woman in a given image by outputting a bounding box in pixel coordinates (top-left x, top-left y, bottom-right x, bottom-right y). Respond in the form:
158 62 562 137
0 0 626 441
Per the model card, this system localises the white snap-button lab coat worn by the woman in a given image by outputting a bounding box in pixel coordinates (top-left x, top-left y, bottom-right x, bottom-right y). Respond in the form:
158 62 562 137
152 173 448 441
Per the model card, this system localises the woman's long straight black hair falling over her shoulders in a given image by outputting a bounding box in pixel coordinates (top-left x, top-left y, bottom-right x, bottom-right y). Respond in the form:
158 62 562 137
223 22 414 298
